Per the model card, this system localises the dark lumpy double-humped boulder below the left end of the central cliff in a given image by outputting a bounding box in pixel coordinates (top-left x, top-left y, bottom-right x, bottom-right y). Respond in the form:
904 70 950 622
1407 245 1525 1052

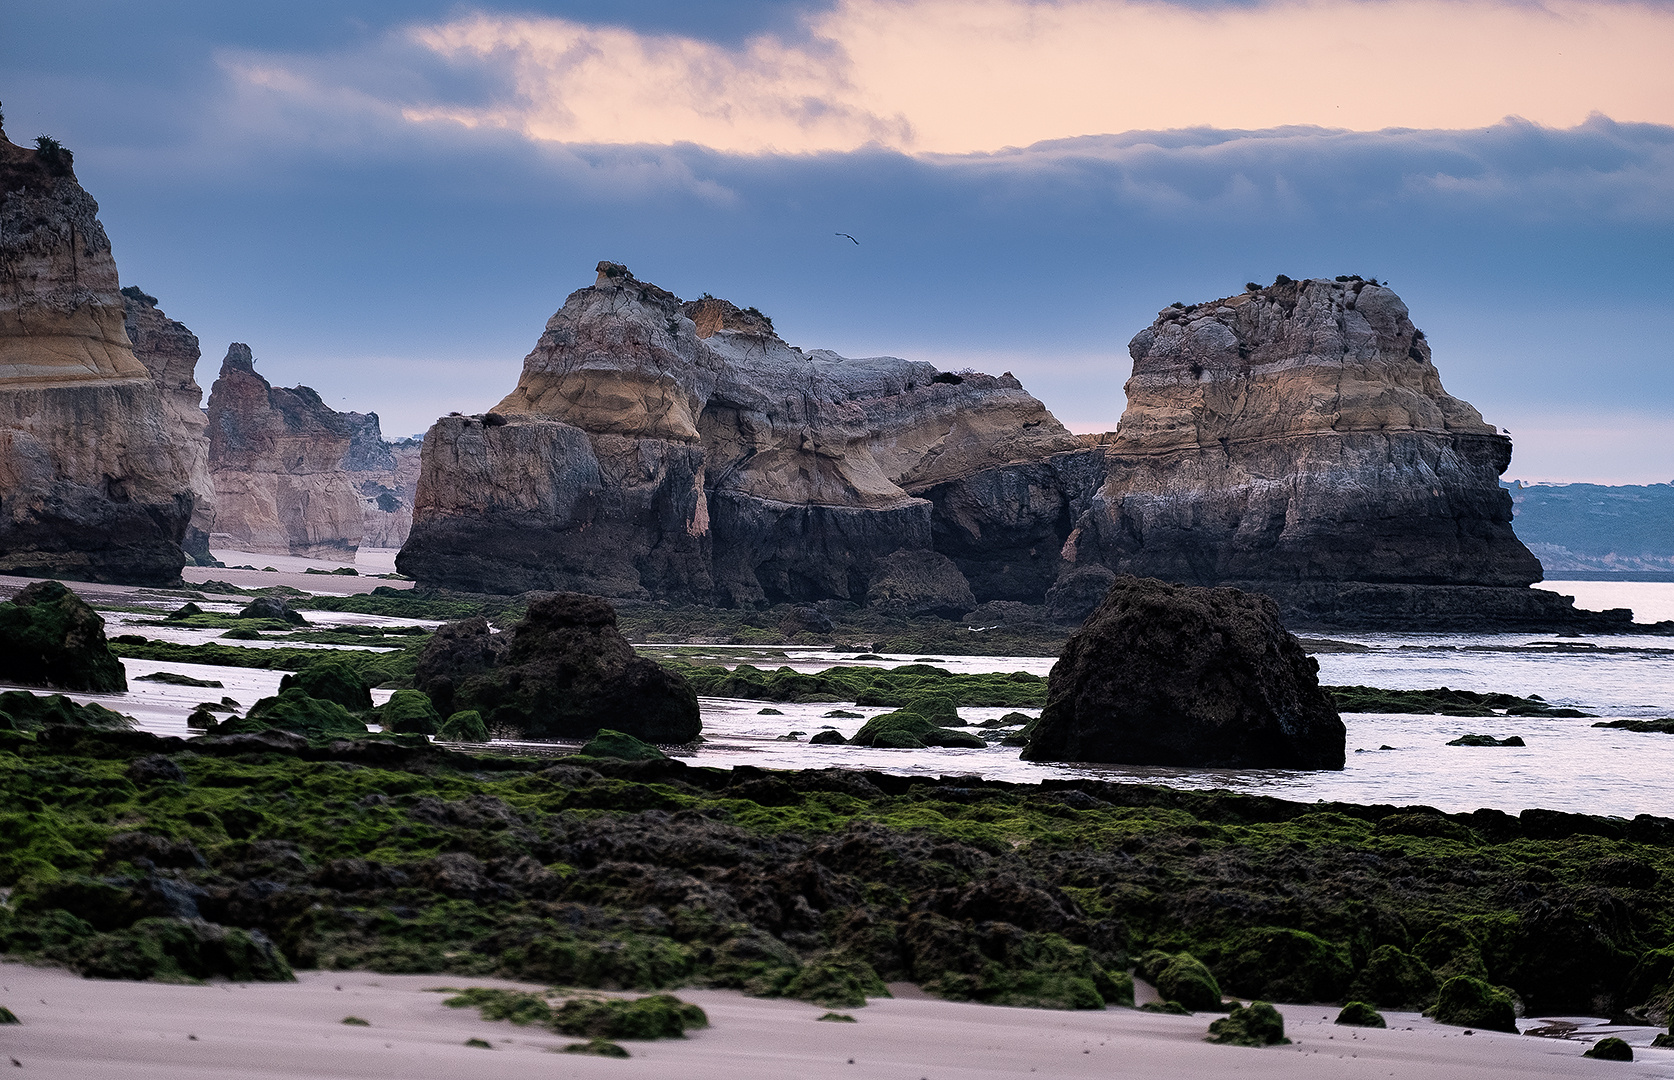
413 593 701 743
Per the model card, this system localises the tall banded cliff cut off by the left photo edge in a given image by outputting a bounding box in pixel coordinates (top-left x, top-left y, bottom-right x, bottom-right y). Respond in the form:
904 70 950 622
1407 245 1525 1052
0 132 193 584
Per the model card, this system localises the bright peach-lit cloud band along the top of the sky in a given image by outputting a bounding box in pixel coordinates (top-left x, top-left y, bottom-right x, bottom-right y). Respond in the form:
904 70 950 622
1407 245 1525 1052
373 0 1674 154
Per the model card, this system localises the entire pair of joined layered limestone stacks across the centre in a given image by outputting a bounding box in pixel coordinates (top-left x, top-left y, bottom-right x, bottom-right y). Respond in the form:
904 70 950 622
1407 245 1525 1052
397 263 1630 630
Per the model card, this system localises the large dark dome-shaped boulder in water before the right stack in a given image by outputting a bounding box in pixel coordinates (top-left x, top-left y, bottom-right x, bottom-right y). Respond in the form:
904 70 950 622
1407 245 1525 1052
1023 576 1346 769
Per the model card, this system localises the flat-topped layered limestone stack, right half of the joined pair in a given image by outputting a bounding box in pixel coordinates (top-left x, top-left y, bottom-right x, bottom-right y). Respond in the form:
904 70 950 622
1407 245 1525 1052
1056 278 1600 623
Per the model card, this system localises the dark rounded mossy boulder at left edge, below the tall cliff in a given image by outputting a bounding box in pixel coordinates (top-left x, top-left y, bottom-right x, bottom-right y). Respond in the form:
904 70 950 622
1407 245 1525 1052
0 581 127 693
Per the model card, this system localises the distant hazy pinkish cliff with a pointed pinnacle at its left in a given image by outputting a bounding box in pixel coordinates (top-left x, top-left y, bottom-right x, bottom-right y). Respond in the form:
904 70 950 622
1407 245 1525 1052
209 343 363 561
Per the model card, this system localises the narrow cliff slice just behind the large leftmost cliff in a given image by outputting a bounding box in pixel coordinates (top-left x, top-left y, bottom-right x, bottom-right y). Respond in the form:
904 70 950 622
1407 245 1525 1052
122 285 214 563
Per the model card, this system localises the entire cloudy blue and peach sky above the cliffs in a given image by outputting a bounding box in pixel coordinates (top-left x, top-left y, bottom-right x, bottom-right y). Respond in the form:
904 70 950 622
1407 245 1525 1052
0 0 1674 484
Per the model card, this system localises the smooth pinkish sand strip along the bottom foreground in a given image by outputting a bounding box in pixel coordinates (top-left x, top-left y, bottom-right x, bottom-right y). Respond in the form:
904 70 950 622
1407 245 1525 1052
0 963 1674 1080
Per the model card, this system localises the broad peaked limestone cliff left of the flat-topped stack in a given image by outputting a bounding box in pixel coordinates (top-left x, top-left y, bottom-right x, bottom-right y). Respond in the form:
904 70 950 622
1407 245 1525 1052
398 263 1075 604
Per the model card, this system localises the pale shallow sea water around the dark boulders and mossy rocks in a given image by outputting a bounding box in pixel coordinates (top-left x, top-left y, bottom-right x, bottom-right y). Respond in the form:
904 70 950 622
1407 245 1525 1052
16 581 1674 817
